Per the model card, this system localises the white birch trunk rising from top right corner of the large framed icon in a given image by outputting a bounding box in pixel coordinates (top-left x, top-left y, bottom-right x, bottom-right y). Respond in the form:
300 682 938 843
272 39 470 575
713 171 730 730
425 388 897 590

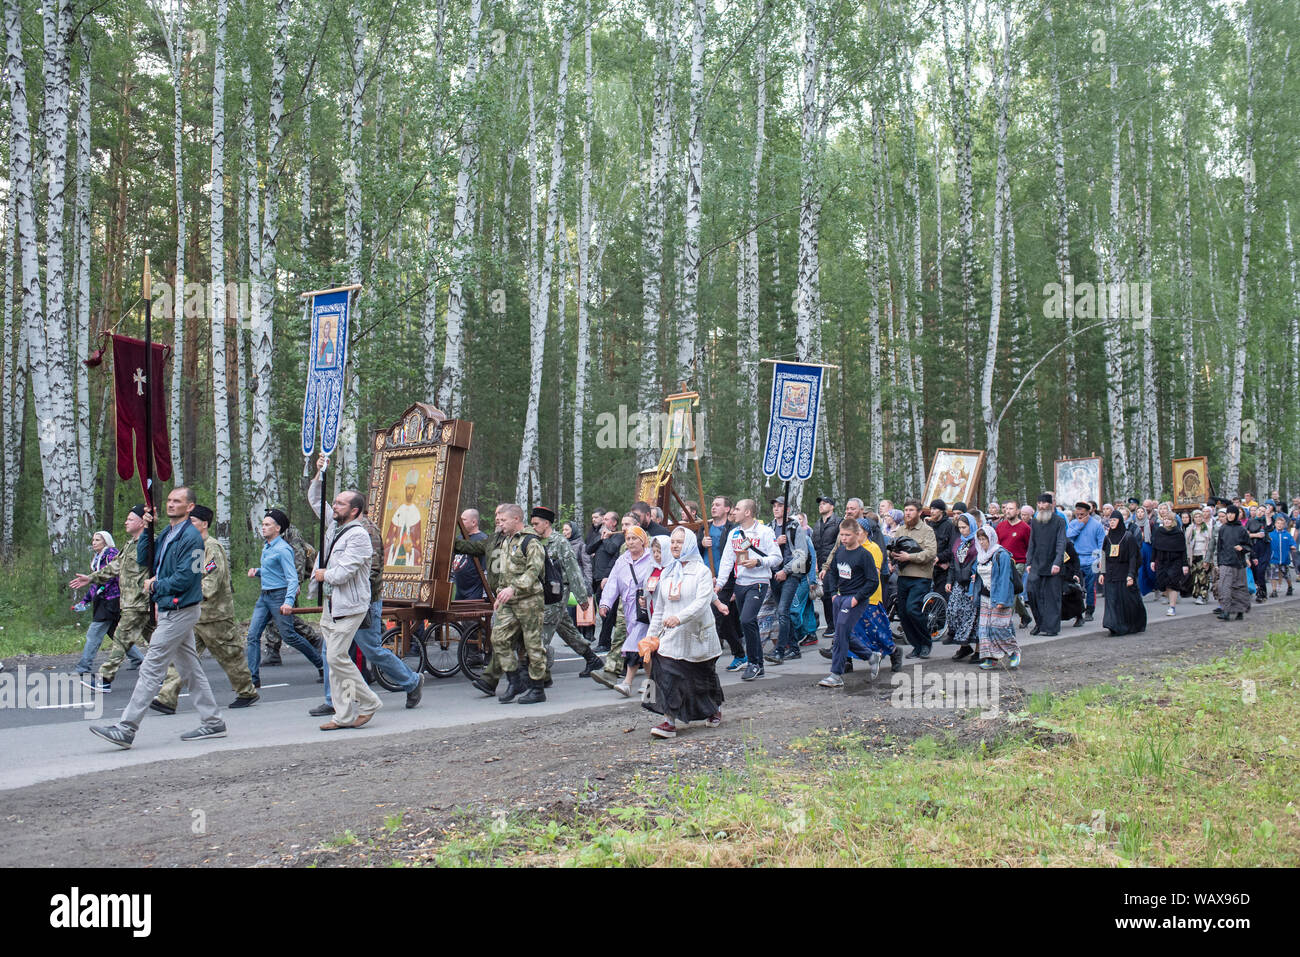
438 0 482 416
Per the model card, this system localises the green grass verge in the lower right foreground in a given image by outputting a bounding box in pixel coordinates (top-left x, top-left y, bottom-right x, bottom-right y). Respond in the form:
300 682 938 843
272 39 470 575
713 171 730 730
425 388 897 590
395 635 1300 867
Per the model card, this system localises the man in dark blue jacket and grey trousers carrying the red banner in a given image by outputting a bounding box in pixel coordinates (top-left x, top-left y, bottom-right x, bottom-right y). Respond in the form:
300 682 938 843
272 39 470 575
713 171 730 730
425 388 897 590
91 485 226 750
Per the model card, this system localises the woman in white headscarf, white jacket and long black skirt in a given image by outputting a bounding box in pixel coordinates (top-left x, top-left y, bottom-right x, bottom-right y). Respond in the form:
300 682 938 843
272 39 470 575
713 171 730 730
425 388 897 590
642 525 723 737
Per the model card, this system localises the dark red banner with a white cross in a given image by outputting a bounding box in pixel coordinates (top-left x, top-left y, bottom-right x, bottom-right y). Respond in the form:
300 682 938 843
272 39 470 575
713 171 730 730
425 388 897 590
113 335 172 502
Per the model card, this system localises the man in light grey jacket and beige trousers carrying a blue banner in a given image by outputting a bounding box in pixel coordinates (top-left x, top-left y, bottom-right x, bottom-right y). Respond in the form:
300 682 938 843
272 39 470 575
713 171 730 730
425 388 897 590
312 489 384 731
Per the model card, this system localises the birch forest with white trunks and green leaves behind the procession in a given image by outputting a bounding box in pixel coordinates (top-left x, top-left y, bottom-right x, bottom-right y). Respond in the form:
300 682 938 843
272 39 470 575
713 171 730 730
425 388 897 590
0 0 1300 571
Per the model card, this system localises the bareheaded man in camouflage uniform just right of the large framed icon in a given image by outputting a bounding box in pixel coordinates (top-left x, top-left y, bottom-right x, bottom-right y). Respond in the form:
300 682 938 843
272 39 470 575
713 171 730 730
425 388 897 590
455 502 546 705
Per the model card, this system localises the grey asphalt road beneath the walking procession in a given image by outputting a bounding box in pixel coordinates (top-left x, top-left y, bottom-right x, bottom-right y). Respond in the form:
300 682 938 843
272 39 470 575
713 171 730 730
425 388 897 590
0 597 1300 791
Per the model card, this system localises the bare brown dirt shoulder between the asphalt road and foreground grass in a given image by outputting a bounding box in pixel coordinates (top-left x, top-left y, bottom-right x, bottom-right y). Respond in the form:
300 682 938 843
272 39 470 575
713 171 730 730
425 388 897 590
0 606 1296 867
